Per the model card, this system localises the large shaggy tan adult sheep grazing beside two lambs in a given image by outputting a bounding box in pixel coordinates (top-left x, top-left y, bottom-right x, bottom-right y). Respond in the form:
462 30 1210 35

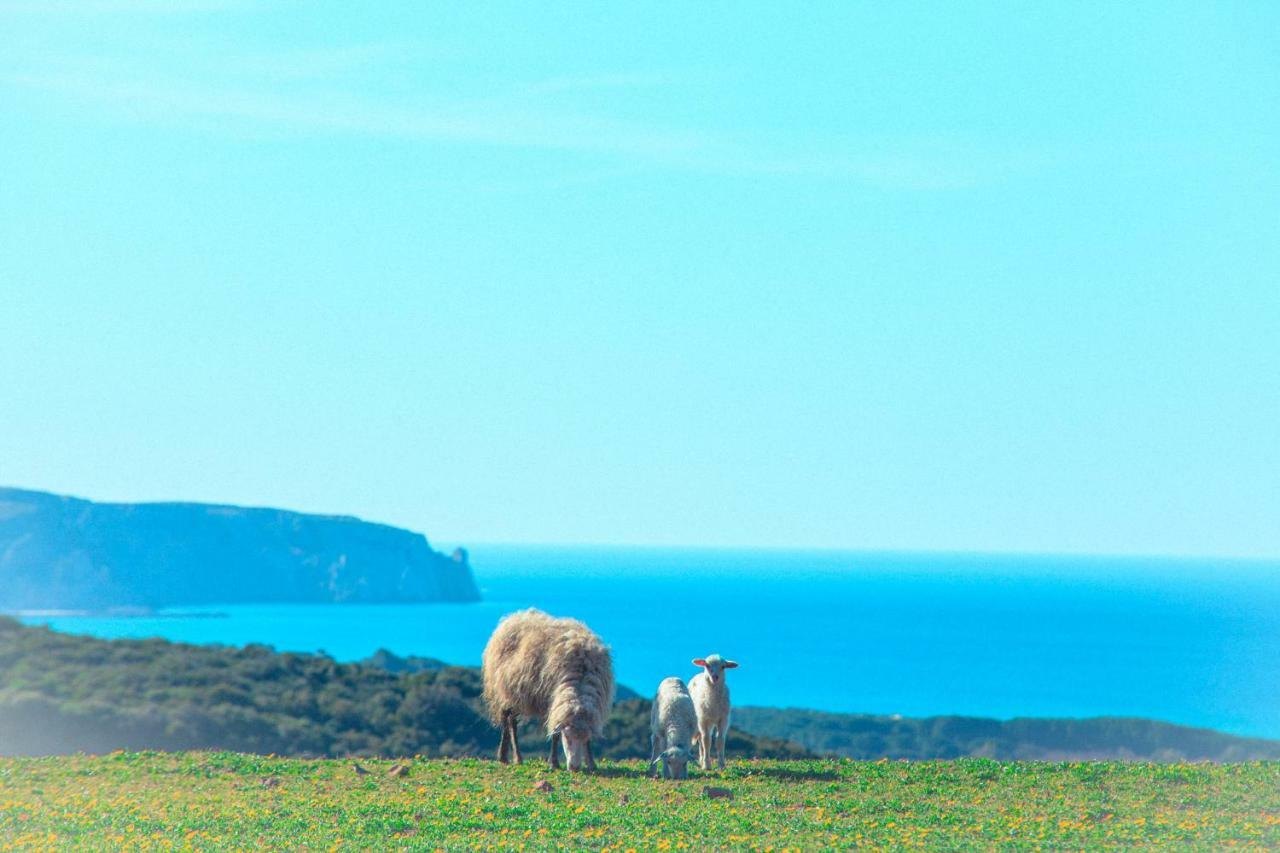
481 608 613 770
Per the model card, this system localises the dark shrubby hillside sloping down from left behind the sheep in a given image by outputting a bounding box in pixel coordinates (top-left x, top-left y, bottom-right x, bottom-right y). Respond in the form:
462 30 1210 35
0 616 810 758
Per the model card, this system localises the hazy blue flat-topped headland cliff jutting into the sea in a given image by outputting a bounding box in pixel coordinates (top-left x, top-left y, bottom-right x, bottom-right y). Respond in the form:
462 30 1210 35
0 488 480 610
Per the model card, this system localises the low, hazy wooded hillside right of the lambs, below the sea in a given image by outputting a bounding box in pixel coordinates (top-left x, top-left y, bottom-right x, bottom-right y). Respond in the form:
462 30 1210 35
733 708 1280 761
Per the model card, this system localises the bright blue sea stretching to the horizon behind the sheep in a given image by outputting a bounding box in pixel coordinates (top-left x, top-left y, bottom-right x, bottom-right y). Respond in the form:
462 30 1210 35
17 546 1280 738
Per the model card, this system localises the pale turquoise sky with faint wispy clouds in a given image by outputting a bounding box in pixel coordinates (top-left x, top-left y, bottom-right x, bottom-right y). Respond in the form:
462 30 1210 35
0 0 1280 557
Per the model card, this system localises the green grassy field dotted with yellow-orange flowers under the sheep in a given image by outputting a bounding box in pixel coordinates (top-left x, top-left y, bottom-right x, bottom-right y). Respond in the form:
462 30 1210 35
0 753 1280 850
